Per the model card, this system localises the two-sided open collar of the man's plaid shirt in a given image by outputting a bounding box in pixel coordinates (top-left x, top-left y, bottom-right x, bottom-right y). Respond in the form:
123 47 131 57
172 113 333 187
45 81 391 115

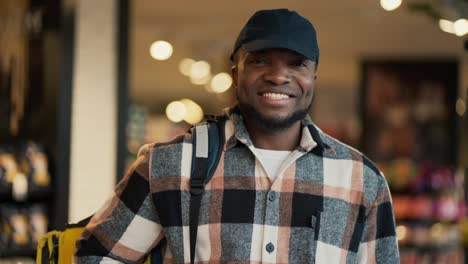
224 107 336 155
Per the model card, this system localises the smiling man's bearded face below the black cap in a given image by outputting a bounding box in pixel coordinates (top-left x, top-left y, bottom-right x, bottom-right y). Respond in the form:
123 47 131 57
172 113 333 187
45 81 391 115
232 49 316 130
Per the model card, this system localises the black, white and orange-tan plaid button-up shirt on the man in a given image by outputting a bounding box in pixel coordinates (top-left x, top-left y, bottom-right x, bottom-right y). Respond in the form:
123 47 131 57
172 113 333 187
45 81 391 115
75 109 399 263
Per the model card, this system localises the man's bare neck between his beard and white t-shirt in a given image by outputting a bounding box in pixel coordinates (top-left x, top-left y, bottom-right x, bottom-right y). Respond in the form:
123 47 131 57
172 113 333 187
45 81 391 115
245 120 302 151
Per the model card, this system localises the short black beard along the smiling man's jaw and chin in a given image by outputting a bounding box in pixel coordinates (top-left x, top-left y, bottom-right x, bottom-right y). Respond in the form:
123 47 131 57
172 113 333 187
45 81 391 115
238 100 312 131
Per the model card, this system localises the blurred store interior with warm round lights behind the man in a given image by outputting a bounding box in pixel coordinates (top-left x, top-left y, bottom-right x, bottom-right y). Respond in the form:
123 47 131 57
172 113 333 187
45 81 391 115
0 0 468 264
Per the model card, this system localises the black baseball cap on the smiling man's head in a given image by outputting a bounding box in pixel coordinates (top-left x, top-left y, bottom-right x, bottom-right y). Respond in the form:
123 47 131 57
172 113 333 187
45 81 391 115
230 9 319 63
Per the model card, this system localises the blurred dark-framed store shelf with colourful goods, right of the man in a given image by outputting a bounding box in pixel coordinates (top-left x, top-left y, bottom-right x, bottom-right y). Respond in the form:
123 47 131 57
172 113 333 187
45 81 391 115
361 60 467 264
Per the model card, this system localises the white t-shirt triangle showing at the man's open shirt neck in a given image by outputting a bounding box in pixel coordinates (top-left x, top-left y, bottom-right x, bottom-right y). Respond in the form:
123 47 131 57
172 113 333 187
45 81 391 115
254 148 292 182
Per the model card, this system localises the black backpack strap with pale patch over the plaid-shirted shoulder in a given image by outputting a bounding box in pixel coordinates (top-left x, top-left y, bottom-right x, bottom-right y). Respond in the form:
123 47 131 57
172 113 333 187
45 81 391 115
189 120 224 264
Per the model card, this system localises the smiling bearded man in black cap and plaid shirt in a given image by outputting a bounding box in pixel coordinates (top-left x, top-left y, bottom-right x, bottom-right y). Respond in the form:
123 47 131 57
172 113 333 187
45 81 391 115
77 9 399 263
